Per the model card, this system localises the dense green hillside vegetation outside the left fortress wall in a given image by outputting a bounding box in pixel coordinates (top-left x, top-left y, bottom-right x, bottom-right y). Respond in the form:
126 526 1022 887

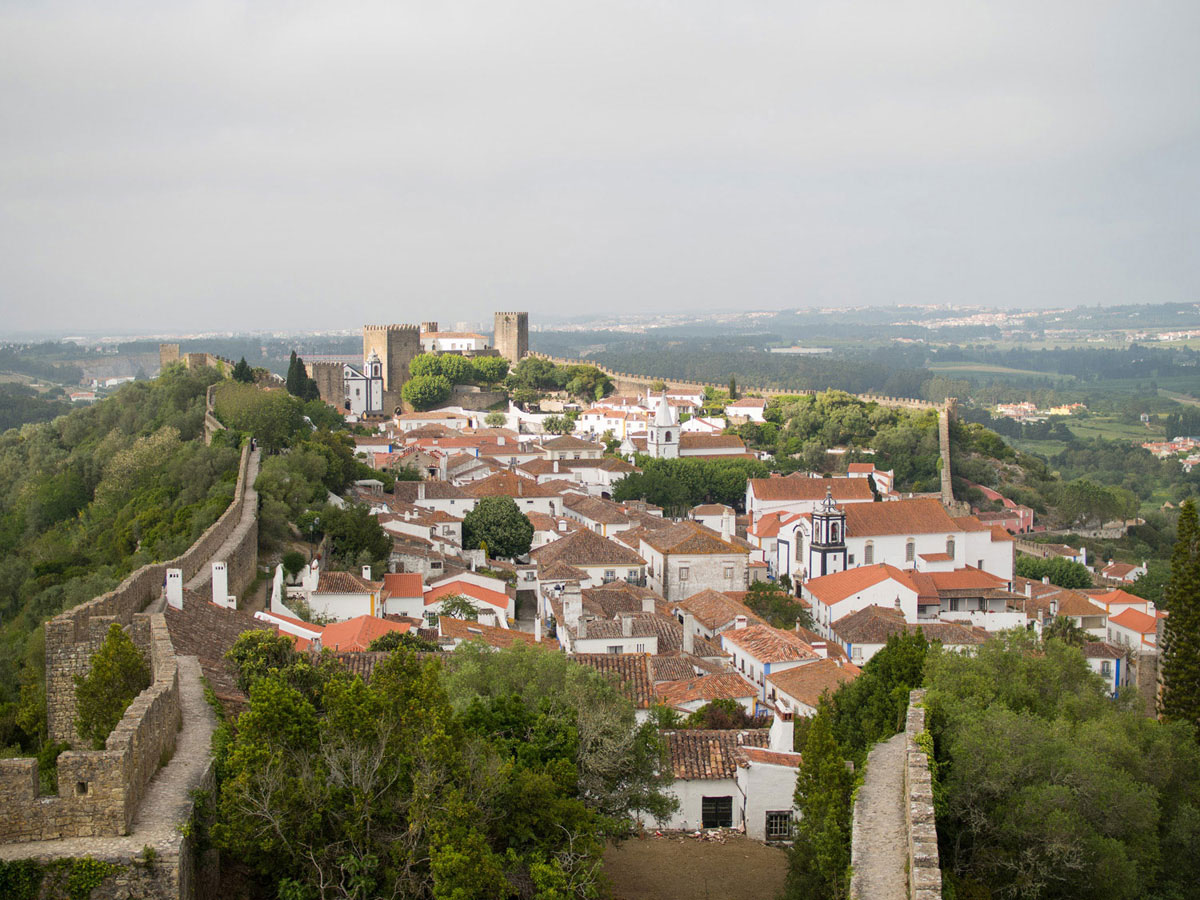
0 366 239 752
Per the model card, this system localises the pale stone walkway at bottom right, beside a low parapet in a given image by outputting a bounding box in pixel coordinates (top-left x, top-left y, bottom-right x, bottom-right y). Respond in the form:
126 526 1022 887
850 732 908 900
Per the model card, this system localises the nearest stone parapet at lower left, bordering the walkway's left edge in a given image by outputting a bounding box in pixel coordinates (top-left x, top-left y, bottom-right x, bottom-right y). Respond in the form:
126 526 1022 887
0 613 180 842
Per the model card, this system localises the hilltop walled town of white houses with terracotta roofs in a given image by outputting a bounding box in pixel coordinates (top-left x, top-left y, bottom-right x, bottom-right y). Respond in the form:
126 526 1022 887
0 312 1190 900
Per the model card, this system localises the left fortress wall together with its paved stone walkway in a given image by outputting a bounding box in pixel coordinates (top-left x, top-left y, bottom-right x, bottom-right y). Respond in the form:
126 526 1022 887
0 446 259 900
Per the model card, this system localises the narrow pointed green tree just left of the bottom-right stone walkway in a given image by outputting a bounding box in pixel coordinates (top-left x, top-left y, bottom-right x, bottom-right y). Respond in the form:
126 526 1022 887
784 702 854 900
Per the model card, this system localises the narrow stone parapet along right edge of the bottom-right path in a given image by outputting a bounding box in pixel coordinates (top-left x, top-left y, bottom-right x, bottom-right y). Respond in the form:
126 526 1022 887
904 690 942 900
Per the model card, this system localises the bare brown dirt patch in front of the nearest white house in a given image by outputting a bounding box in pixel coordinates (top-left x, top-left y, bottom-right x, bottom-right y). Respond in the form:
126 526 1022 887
604 835 787 900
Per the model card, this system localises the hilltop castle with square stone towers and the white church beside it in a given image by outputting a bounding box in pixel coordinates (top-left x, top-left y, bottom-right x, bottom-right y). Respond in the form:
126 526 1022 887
306 312 529 416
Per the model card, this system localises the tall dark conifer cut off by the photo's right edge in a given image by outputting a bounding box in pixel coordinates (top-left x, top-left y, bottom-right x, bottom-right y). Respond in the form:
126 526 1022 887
1159 500 1200 736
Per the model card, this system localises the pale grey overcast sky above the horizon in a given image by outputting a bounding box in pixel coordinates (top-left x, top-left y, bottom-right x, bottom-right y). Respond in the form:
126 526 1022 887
0 0 1200 332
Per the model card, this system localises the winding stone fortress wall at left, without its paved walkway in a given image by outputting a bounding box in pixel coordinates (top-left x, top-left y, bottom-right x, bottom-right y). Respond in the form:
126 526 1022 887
0 446 258 842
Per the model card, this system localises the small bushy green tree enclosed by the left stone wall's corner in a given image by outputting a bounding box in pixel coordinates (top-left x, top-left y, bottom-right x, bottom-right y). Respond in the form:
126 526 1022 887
76 622 150 750
